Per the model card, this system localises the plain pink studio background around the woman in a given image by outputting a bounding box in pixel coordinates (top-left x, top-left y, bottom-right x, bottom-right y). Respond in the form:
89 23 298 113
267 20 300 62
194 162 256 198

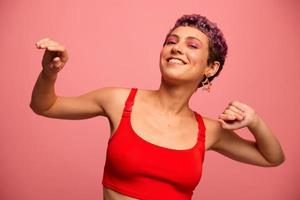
0 0 300 200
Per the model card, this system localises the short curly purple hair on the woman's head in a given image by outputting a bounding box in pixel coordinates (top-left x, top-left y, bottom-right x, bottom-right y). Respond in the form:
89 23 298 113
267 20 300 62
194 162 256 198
167 14 227 87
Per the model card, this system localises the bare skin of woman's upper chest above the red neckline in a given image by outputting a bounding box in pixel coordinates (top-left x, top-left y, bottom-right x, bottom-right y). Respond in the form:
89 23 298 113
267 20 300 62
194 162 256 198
130 108 199 150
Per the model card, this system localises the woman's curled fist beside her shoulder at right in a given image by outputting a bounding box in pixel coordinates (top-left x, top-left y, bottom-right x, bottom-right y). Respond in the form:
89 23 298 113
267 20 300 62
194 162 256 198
218 101 258 130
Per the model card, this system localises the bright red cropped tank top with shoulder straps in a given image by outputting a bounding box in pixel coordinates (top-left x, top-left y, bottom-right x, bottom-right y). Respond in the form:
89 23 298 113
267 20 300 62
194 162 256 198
102 88 205 200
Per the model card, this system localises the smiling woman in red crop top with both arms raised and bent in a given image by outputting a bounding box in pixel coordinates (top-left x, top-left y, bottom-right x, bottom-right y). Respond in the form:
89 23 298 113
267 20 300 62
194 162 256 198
30 15 284 200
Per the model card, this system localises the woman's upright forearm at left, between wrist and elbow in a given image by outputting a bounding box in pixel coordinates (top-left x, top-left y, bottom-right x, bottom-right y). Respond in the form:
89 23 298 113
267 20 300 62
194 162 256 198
30 71 57 114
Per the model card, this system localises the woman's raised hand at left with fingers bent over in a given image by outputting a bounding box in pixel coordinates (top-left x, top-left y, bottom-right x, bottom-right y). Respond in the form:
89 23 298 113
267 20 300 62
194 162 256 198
35 38 68 76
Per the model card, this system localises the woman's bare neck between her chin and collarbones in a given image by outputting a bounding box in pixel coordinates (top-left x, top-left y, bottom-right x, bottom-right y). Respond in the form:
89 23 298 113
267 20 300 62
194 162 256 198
156 79 195 115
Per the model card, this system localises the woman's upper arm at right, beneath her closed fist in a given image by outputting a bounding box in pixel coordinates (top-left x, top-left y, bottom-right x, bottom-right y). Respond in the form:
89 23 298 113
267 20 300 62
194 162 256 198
207 120 273 167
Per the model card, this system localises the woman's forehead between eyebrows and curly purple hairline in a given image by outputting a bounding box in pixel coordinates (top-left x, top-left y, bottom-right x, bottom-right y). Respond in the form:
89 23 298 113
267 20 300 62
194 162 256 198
170 26 209 46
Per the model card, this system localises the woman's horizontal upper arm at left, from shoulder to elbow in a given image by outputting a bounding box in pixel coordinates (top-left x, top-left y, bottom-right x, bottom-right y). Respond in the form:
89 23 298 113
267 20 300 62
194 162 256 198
39 88 125 119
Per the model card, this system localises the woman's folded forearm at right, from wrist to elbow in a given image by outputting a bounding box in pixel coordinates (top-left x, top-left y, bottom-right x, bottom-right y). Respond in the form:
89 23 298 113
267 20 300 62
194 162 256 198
248 116 285 165
